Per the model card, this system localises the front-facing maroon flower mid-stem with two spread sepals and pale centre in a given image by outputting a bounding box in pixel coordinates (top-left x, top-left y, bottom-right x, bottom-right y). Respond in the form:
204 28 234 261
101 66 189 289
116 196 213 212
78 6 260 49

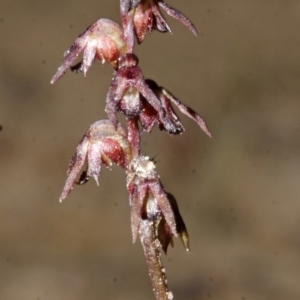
105 54 182 134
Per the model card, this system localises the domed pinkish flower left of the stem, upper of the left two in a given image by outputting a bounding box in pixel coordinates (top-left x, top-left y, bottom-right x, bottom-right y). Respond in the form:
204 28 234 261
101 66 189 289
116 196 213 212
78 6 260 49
51 19 126 83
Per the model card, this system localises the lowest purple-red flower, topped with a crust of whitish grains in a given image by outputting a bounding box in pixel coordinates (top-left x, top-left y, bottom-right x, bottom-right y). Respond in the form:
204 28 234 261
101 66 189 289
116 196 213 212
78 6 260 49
127 156 189 252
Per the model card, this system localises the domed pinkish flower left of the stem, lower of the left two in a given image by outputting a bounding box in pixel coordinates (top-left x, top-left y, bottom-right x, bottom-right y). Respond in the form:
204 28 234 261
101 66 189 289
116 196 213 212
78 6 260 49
60 120 131 201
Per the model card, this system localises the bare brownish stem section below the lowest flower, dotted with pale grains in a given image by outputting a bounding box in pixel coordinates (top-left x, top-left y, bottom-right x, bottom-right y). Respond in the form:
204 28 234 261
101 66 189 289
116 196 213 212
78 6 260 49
139 220 173 300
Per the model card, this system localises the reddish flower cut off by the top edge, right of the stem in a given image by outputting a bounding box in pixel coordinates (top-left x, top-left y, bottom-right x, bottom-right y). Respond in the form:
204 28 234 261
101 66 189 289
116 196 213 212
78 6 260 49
133 0 197 43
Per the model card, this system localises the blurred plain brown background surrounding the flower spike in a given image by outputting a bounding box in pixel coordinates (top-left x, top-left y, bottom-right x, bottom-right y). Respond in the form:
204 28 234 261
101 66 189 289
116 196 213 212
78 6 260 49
0 0 300 300
